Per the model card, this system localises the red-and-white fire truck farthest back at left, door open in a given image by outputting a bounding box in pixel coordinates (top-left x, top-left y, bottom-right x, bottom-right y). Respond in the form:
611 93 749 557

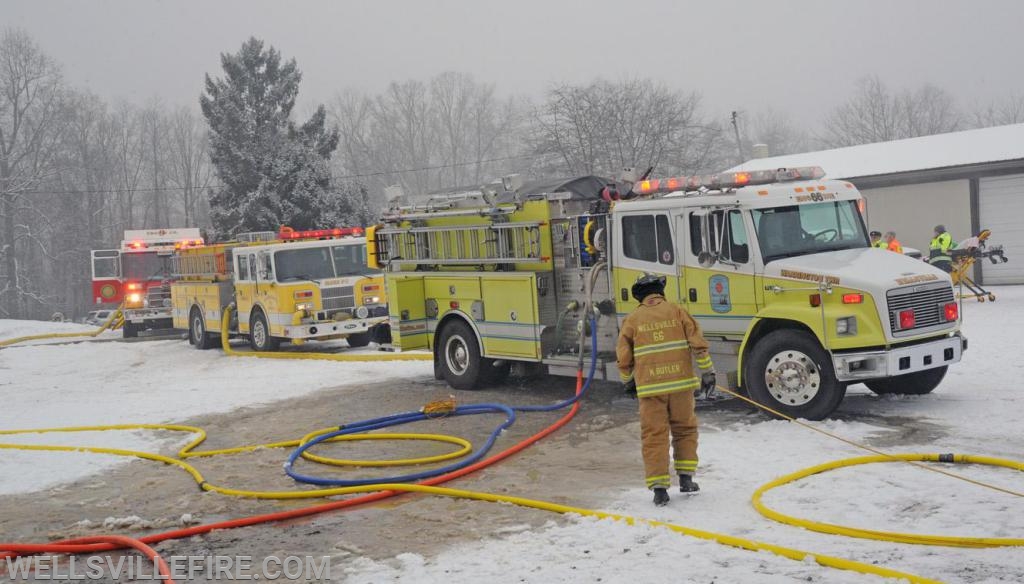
92 227 203 338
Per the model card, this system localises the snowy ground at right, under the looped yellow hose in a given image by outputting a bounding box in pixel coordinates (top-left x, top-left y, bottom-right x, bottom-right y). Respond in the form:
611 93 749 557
346 287 1024 584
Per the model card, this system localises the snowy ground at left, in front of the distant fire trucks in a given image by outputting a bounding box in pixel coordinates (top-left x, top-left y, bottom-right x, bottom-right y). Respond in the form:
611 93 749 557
0 321 432 495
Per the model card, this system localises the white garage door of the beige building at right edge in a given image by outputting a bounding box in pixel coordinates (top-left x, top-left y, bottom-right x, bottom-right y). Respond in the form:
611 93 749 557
979 174 1024 285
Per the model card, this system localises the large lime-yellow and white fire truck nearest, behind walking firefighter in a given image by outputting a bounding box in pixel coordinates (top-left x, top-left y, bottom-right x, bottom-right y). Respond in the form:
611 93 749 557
368 167 967 419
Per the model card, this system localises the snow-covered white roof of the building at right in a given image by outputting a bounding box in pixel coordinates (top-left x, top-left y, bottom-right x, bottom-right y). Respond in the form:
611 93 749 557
730 124 1024 178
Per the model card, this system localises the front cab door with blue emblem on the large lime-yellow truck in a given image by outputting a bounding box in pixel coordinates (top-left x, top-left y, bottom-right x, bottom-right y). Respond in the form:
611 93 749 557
677 209 758 336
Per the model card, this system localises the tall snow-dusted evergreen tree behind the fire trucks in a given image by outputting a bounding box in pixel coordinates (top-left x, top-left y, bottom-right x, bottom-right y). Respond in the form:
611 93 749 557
200 38 353 237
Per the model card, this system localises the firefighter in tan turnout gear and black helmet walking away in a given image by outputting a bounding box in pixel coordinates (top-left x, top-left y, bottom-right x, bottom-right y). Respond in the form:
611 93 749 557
615 274 715 506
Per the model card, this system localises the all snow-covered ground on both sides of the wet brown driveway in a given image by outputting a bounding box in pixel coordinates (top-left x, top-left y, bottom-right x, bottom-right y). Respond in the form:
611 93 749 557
0 287 1024 584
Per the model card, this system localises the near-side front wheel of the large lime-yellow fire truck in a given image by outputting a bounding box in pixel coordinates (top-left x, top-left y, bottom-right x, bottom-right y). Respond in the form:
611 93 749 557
743 329 846 420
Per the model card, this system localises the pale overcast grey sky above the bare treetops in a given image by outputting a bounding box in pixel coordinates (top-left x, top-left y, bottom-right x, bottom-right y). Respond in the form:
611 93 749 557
8 0 1024 126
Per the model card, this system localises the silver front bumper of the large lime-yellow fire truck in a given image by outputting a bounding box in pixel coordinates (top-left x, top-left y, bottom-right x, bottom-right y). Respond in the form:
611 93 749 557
833 333 967 381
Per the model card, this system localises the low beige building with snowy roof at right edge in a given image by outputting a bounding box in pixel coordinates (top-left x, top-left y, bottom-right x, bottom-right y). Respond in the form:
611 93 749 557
735 124 1024 285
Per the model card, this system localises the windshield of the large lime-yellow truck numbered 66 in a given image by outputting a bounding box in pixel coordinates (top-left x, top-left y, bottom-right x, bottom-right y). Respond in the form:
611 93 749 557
753 201 868 263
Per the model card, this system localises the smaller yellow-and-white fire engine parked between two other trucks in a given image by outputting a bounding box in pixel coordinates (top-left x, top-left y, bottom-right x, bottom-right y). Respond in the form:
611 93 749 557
171 227 389 350
